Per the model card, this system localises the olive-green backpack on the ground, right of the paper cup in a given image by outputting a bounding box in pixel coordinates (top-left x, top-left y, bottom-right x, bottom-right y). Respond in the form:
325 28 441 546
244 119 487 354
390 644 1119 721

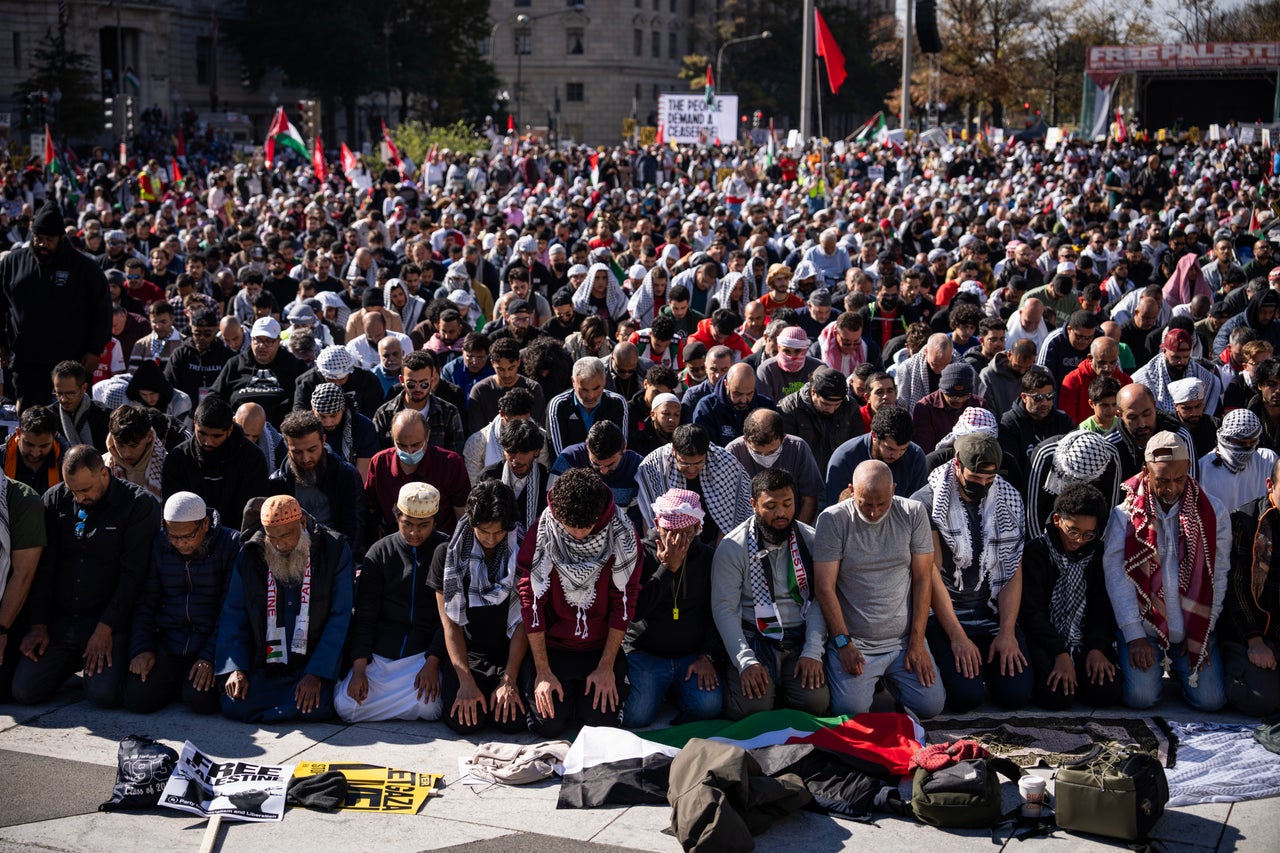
1053 745 1169 841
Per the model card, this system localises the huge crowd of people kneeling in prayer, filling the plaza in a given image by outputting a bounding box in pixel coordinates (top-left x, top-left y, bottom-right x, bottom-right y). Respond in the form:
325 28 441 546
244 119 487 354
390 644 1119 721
0 129 1280 736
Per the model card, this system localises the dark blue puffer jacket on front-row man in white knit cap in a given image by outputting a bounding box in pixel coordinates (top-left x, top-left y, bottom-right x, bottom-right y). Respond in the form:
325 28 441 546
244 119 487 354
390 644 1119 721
129 514 239 663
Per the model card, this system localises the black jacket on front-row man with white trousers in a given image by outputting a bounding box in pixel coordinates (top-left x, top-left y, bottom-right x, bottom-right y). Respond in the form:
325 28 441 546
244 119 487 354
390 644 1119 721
348 530 449 661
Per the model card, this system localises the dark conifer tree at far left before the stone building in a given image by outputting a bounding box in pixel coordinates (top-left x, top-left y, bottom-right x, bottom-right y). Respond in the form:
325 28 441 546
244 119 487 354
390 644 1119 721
14 27 102 140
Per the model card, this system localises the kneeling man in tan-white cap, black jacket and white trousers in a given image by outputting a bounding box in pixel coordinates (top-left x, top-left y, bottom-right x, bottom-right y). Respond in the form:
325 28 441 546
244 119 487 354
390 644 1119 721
333 483 448 722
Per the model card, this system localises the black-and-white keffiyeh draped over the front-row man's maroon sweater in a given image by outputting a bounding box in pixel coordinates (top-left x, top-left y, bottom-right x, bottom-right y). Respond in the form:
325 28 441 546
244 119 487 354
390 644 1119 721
529 507 640 637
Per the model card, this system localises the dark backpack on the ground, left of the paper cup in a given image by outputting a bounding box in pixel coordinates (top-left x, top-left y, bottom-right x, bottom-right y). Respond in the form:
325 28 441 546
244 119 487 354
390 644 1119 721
911 740 1023 829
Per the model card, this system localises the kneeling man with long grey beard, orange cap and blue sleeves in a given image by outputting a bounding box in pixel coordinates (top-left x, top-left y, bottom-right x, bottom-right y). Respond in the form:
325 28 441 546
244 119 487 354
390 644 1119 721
214 494 355 722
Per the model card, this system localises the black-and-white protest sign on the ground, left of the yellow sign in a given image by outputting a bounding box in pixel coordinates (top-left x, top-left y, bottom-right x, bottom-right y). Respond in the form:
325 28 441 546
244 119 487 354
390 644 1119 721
160 740 293 821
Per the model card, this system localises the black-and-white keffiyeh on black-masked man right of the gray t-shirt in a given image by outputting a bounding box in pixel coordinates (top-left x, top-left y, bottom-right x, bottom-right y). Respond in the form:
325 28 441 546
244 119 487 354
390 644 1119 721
929 462 1027 607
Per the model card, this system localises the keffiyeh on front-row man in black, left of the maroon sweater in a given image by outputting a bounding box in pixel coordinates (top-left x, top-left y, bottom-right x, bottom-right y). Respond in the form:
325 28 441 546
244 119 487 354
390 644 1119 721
443 516 525 637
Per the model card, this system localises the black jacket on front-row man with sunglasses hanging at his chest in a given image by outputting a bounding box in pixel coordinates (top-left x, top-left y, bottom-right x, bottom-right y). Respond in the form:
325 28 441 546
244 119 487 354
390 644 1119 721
27 476 160 642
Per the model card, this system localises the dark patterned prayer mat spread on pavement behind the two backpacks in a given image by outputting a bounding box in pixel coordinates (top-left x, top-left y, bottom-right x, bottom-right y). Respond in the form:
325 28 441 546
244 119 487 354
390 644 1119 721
920 716 1178 767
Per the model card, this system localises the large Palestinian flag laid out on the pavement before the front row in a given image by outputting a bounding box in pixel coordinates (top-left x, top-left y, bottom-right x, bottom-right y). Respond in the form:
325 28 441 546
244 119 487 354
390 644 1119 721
557 711 924 808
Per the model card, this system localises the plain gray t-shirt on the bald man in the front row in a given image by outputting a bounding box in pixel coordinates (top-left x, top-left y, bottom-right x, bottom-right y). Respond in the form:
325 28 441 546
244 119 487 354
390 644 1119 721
813 496 933 654
